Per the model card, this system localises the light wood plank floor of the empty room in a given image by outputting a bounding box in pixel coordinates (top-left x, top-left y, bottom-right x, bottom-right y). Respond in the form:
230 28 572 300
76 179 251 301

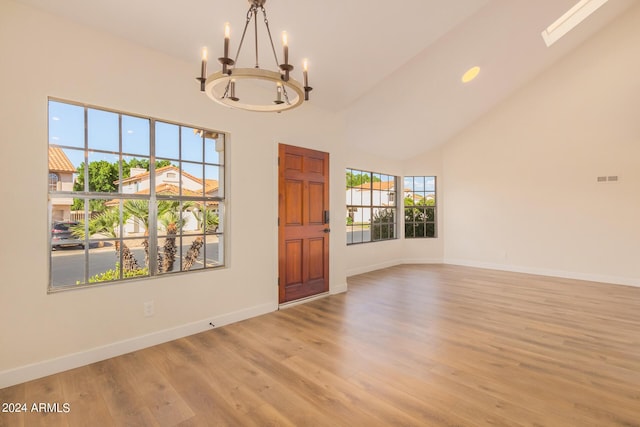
0 265 640 427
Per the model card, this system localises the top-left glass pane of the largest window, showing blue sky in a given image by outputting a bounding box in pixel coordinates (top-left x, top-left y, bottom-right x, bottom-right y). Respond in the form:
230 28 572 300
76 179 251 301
49 101 84 148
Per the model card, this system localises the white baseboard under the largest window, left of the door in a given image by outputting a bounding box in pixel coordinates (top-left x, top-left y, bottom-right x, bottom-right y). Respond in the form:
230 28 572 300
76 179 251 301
0 304 277 388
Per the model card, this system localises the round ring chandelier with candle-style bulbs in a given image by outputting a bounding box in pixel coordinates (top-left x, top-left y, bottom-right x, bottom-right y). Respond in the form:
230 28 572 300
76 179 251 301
196 0 313 112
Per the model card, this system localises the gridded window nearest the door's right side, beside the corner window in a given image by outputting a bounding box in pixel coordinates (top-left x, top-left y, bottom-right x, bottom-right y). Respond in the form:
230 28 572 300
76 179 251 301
346 169 398 245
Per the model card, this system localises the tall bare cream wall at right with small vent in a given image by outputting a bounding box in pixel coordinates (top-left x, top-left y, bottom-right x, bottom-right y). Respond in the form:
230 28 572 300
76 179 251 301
443 6 640 285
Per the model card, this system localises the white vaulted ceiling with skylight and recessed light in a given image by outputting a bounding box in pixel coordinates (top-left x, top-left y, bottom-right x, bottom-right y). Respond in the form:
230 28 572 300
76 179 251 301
16 0 634 157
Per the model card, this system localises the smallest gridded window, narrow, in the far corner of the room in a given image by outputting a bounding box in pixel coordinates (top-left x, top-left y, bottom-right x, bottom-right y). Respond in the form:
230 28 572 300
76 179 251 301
403 176 437 238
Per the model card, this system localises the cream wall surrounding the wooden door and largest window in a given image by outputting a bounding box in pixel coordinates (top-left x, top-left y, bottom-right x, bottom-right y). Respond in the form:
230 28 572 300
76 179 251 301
0 0 346 388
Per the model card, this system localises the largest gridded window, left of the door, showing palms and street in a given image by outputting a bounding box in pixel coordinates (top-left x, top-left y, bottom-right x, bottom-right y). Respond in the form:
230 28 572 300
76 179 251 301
48 99 225 290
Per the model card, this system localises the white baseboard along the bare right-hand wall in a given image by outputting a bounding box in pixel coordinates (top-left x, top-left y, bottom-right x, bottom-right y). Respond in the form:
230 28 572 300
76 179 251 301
444 259 640 287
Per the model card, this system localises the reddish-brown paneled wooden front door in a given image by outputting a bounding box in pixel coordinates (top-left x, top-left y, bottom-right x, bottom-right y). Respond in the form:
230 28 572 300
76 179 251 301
278 144 329 304
